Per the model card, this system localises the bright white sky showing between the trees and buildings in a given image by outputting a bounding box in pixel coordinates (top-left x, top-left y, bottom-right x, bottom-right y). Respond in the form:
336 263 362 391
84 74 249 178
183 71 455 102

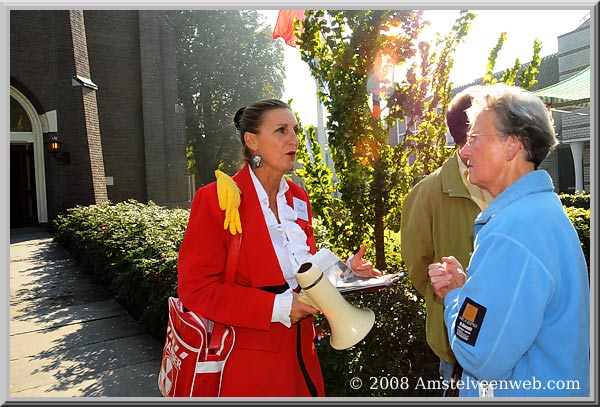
261 9 589 125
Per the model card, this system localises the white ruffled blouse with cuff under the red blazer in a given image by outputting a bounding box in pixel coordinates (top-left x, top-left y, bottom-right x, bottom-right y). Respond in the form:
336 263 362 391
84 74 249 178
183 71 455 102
250 171 312 328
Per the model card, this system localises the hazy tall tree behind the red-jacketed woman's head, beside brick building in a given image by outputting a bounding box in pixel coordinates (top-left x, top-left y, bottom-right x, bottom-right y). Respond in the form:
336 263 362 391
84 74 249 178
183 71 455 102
168 10 285 186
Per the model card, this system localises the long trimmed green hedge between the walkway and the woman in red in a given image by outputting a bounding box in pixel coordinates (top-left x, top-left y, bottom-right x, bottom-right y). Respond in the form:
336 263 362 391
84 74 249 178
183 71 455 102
53 200 189 341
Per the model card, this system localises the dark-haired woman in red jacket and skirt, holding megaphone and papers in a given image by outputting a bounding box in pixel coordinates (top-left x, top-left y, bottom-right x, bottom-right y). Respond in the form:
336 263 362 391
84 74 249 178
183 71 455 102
178 99 381 397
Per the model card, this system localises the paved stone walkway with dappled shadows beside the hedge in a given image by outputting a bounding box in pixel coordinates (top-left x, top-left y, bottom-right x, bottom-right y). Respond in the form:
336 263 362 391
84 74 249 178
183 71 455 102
9 228 162 401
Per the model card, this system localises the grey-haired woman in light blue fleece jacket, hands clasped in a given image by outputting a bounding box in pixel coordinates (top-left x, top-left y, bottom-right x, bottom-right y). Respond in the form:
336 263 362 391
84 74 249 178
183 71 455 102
429 84 590 397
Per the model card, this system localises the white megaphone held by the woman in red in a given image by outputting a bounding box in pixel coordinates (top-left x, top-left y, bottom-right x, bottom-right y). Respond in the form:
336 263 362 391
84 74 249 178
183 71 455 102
296 263 375 350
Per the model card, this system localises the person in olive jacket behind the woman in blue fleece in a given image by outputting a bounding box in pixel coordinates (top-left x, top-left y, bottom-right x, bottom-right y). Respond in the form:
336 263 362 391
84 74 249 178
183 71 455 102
400 87 492 396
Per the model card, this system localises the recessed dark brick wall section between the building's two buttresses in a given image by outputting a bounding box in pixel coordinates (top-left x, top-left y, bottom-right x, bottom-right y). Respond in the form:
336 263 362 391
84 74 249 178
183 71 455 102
85 10 148 202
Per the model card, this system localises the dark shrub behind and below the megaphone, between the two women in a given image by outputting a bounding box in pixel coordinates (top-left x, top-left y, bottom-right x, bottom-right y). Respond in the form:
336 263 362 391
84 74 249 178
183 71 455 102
316 279 442 397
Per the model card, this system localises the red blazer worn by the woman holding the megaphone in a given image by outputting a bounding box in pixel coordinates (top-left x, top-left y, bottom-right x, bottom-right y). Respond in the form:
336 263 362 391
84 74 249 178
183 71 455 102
178 165 323 395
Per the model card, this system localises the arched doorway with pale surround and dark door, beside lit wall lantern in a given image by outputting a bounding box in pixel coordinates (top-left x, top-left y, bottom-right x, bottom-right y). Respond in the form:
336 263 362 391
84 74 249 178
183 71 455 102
10 86 48 228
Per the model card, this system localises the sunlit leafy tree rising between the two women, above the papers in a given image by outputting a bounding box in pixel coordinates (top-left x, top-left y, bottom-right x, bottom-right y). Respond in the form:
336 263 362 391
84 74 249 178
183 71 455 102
298 10 474 269
